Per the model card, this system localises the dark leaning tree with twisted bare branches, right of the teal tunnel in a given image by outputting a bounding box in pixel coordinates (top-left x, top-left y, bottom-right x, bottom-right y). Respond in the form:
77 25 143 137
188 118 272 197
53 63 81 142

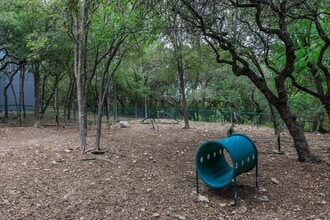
180 0 313 161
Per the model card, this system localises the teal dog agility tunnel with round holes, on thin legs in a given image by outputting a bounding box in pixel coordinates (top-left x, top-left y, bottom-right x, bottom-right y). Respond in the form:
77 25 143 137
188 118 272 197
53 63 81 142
196 134 258 205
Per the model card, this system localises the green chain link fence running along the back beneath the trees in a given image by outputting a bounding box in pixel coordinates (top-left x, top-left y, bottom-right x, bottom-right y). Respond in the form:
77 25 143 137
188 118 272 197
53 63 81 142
0 105 330 132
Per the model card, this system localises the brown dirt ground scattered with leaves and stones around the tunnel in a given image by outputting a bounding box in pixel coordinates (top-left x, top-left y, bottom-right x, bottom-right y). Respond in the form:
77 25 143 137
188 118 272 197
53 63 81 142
0 121 330 220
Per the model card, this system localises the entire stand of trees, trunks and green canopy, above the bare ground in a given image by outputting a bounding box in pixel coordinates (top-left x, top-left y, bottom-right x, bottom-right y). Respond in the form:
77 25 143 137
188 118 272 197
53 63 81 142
0 0 330 161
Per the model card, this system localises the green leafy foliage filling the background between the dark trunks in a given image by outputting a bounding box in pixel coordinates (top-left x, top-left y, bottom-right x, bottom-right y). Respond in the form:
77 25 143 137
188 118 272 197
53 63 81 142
0 0 330 126
